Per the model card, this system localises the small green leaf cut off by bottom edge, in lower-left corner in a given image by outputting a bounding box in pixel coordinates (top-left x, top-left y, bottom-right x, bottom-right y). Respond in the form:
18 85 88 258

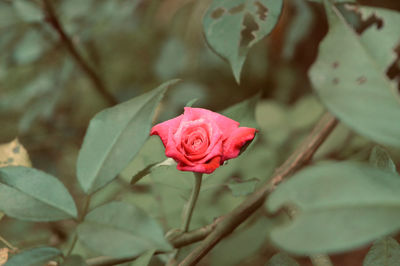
4 247 62 266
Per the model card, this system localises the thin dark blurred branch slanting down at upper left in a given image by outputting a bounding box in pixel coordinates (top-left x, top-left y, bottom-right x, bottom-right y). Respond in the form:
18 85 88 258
43 0 118 106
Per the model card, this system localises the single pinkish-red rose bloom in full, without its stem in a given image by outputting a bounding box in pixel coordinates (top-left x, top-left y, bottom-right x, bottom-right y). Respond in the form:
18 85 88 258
150 107 256 174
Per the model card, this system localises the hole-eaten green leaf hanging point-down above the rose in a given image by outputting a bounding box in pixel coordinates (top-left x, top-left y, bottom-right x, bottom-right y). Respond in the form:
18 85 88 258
203 0 283 83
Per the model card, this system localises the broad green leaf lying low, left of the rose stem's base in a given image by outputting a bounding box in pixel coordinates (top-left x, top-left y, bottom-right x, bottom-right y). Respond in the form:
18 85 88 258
78 202 171 258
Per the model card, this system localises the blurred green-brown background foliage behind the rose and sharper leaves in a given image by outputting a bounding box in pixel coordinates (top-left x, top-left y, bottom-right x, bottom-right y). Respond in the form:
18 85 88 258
0 0 400 265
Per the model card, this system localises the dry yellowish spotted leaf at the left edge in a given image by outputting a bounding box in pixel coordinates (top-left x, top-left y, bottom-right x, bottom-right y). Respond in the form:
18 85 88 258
0 138 32 167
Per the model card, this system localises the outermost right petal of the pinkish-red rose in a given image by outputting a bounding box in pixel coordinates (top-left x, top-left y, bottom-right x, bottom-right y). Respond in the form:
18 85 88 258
222 127 257 161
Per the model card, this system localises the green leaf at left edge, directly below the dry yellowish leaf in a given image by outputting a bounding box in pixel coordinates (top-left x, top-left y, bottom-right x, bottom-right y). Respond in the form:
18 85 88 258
0 166 77 221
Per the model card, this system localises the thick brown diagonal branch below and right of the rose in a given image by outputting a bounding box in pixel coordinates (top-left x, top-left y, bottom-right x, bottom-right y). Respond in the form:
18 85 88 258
179 113 338 266
